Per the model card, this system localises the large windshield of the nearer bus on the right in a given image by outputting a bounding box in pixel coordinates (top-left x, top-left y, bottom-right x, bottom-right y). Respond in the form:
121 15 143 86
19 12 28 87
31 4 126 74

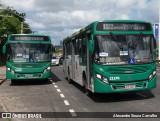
94 34 154 65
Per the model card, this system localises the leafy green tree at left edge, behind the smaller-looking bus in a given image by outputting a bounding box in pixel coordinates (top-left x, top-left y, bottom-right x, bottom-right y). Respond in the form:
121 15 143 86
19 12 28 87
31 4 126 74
0 2 32 65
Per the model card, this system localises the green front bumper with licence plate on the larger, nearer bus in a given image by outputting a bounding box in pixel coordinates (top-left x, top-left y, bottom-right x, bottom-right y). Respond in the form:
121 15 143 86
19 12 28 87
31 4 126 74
94 75 157 93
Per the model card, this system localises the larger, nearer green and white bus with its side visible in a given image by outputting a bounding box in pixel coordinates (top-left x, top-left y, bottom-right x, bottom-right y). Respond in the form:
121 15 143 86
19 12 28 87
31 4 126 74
63 20 157 93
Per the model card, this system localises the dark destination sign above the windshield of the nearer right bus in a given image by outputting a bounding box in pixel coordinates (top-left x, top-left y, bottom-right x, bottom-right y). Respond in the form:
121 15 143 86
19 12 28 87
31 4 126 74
97 22 151 31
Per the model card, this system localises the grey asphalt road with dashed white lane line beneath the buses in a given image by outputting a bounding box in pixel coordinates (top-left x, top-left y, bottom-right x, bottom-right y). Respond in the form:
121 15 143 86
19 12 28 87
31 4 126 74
0 66 160 121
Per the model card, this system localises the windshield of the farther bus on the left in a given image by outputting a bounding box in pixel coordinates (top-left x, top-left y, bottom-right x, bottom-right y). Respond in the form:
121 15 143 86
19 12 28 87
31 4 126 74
7 43 50 62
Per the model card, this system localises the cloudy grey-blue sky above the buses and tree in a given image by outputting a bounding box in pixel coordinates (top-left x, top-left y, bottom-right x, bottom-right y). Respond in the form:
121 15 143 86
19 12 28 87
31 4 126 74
0 0 160 45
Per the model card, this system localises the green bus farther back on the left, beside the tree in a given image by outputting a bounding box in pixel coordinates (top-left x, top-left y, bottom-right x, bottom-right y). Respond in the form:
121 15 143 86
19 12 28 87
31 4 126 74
3 34 52 83
